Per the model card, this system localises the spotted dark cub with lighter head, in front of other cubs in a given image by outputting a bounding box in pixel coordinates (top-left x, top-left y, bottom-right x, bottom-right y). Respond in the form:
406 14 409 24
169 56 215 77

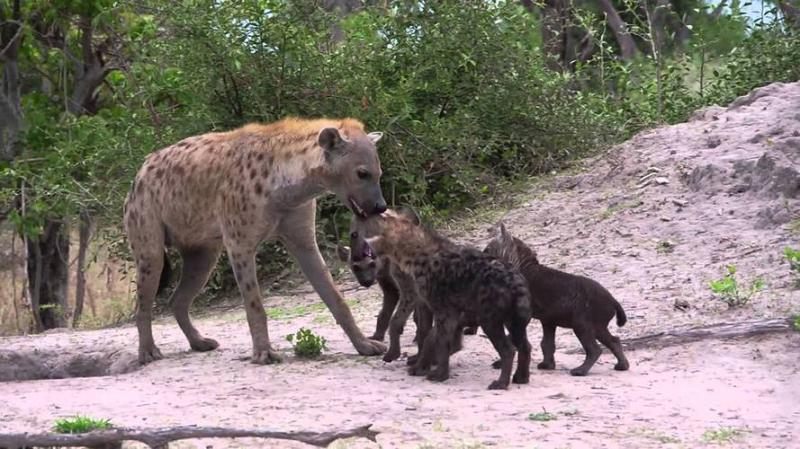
358 210 531 390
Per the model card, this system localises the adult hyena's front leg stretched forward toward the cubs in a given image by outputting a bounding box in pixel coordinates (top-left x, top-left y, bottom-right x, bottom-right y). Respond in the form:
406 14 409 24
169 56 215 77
280 205 386 355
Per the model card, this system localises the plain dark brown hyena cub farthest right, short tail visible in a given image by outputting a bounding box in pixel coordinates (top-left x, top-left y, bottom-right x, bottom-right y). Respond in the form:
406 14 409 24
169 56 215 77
484 222 629 376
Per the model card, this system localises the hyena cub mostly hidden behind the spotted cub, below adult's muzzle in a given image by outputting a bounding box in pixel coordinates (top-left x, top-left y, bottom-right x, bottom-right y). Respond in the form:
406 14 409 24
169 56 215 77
337 209 477 365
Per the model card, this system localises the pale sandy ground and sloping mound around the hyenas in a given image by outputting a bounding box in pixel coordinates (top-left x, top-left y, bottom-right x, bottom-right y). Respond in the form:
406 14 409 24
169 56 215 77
0 83 800 448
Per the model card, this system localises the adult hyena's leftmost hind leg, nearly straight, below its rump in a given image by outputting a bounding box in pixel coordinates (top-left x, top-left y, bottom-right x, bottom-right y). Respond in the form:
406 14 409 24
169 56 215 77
125 207 164 365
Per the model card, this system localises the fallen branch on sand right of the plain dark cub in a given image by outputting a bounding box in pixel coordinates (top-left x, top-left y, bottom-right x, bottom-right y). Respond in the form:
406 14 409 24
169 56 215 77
567 318 794 354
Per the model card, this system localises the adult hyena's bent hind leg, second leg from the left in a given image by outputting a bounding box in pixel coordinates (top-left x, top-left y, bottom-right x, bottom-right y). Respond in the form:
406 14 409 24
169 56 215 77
170 245 221 351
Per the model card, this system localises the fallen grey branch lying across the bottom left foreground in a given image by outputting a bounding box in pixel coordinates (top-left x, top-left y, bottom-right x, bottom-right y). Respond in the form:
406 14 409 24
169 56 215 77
0 424 378 448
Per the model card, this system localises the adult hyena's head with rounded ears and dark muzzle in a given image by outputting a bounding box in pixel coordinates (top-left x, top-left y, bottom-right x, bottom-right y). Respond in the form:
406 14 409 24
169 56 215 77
318 128 386 218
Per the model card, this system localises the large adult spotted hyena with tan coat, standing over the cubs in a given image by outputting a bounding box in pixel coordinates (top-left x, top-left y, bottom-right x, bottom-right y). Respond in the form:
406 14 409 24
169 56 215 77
124 118 386 364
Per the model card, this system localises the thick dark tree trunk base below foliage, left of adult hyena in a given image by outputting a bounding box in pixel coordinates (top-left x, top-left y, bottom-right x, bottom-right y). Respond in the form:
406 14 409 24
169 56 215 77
27 220 69 331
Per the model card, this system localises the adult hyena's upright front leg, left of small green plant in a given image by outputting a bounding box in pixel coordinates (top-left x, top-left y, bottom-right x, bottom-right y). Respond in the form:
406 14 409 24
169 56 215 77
227 245 281 365
